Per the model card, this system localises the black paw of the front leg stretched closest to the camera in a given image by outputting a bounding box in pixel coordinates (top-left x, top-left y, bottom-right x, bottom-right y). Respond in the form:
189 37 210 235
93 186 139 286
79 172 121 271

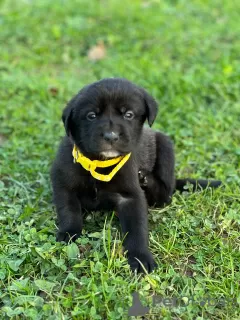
128 251 157 273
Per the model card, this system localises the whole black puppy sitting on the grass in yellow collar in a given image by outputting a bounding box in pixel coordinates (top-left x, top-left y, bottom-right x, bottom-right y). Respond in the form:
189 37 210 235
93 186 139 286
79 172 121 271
51 78 220 272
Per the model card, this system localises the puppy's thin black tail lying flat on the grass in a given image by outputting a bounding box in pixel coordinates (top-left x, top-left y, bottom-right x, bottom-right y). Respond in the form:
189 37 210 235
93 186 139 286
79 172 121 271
175 178 222 191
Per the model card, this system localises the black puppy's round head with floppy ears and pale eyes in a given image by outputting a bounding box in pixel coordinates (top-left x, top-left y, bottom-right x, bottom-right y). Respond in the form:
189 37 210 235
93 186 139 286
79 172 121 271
62 78 157 159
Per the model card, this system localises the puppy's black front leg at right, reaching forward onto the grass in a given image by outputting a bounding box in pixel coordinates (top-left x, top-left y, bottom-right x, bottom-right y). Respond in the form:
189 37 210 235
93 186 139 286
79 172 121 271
117 189 156 272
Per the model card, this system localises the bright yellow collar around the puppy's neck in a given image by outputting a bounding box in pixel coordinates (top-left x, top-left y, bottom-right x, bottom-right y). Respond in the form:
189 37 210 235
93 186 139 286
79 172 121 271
72 145 131 182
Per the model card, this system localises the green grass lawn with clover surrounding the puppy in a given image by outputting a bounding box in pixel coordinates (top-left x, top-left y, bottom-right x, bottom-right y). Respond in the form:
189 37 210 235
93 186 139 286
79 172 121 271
0 0 240 320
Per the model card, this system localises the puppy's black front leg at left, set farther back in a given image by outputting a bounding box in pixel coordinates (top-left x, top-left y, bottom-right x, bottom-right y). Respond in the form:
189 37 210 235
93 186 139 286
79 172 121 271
53 188 82 242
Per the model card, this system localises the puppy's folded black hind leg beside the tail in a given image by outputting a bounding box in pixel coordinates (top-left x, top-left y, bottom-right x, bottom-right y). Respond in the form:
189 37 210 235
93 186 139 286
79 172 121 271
140 132 175 207
